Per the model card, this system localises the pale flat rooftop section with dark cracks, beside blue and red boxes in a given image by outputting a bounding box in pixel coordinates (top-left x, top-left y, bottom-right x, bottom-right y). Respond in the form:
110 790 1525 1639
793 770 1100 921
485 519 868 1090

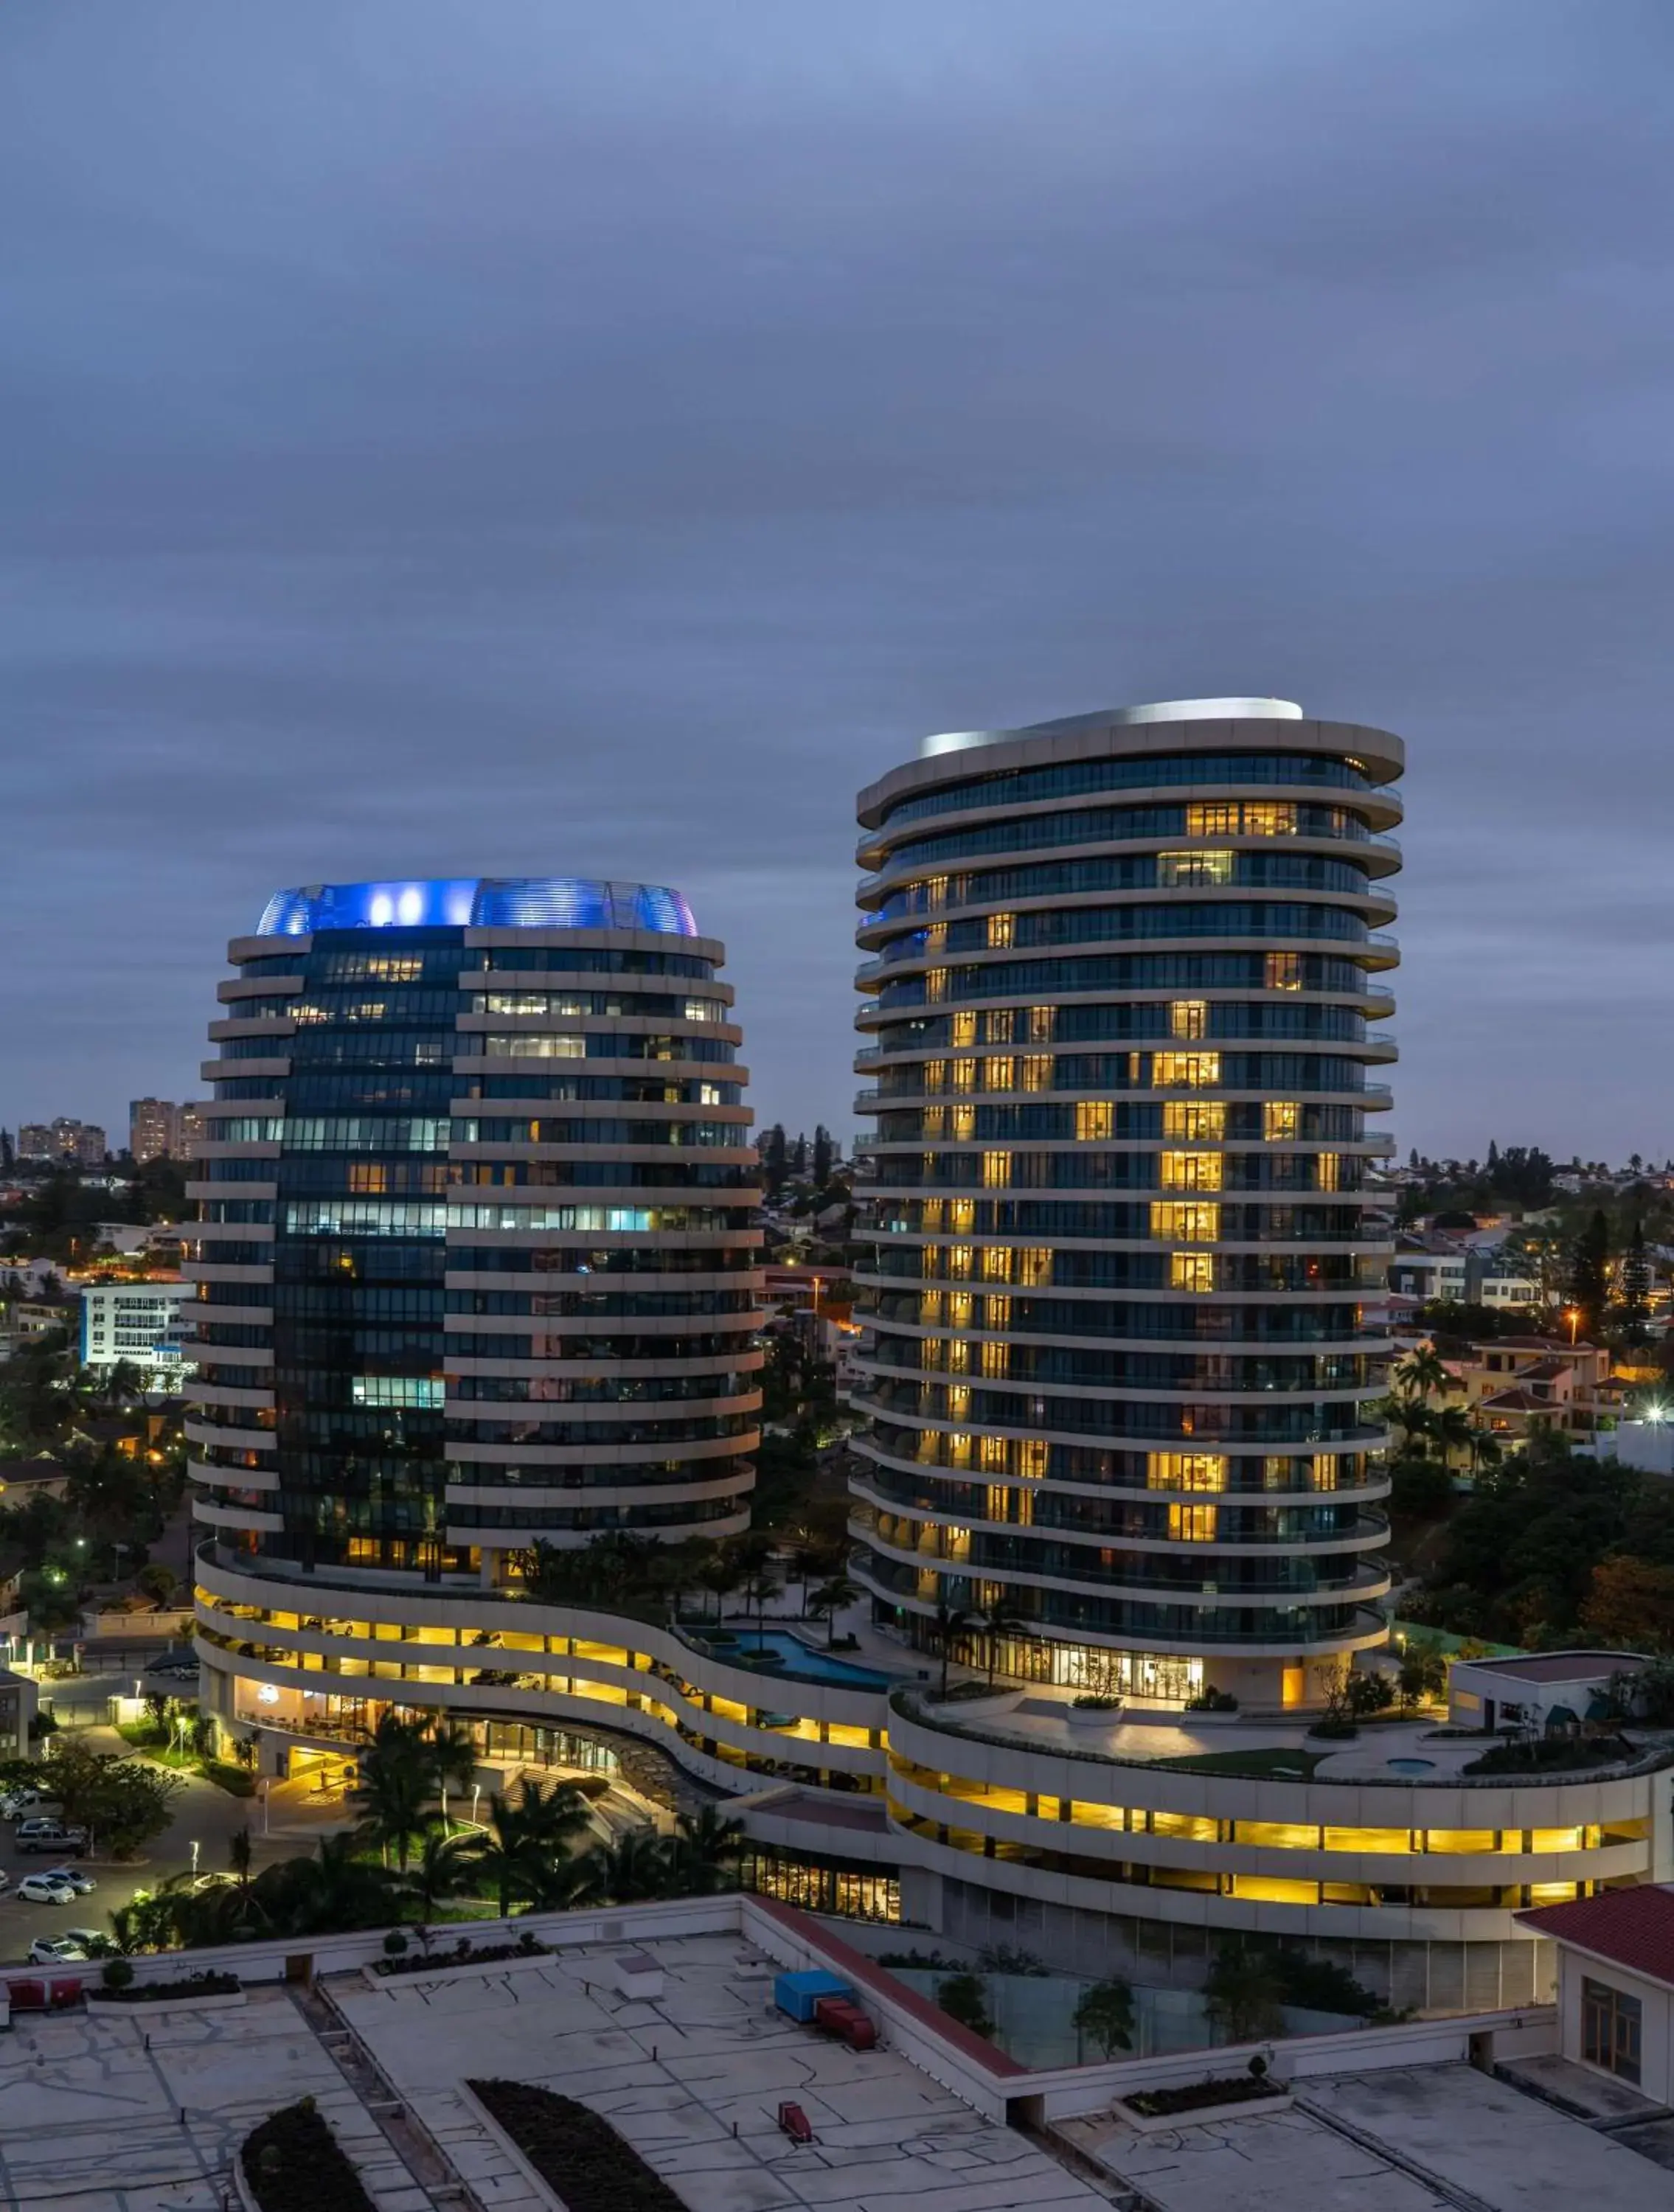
332 1933 1103 2212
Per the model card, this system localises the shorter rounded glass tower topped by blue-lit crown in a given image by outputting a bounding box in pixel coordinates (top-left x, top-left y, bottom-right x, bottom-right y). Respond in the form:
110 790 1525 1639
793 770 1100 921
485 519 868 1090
188 878 761 1590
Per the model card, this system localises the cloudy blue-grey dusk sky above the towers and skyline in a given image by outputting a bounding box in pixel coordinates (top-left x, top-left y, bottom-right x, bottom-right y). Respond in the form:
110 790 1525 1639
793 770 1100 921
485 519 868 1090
0 0 1674 1159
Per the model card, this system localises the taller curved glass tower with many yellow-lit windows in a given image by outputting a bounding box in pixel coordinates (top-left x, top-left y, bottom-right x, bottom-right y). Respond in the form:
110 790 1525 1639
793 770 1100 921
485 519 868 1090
855 699 1402 1710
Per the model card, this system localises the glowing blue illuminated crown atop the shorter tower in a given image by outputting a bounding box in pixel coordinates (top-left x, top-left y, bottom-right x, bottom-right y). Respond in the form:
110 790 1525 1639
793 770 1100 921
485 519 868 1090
257 876 697 938
